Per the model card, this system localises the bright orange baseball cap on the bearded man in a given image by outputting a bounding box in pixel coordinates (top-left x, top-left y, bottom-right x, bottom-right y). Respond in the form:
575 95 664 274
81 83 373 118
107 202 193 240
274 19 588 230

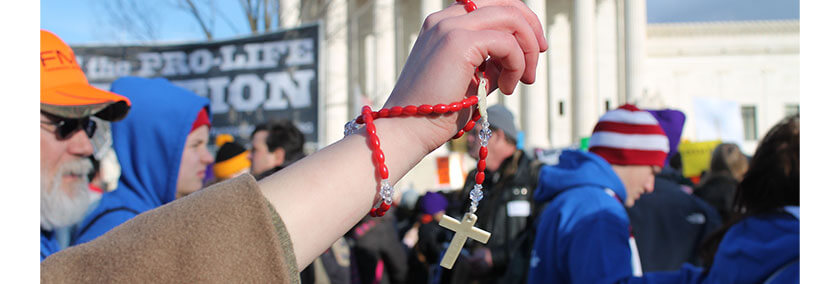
40 30 131 121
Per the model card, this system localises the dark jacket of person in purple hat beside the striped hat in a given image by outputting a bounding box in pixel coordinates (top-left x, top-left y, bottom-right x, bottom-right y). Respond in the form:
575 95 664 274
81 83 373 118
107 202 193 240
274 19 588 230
627 168 721 272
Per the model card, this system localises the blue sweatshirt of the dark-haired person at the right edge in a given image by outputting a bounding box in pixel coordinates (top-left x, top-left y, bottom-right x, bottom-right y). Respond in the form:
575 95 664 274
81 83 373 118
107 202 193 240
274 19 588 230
634 206 799 283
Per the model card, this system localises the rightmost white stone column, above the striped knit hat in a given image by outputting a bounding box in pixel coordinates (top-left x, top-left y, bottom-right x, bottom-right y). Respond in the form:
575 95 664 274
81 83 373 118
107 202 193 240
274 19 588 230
624 0 647 103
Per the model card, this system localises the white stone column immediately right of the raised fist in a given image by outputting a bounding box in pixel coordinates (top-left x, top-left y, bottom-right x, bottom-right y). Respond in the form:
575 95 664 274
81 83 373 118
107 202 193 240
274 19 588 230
520 0 550 148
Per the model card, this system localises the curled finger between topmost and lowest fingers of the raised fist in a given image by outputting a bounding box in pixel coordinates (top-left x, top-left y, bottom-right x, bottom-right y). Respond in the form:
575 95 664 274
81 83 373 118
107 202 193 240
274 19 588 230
437 6 540 84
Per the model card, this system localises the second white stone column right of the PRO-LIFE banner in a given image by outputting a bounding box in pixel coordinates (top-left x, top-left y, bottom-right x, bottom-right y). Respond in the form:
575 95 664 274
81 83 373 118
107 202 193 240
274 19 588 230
372 0 397 106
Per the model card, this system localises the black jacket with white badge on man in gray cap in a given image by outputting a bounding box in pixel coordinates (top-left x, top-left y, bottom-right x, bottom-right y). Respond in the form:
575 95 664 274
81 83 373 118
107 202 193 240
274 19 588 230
447 150 542 283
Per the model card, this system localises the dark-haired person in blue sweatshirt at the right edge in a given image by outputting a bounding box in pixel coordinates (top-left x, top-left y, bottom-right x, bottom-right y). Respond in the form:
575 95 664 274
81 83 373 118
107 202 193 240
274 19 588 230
634 114 799 283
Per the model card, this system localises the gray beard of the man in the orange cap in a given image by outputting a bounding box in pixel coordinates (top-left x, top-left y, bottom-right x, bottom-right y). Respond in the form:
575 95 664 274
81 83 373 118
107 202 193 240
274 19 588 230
41 159 95 231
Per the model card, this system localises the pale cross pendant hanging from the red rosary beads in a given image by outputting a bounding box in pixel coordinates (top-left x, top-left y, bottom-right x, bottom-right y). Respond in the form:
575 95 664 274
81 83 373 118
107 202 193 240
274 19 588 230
438 213 490 269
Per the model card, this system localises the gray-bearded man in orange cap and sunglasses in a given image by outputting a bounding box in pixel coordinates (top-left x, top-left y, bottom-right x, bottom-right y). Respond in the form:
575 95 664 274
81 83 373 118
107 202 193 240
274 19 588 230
40 30 131 260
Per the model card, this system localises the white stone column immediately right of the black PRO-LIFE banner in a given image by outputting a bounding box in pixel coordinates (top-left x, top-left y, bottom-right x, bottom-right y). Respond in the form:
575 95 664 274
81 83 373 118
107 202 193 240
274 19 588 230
321 1 351 146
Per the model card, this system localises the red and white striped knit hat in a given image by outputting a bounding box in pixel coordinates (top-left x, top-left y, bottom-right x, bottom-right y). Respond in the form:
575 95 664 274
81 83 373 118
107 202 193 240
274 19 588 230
589 104 669 167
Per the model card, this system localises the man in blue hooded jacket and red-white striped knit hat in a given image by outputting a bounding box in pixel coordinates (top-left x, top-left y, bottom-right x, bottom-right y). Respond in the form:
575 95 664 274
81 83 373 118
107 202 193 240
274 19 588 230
528 105 669 283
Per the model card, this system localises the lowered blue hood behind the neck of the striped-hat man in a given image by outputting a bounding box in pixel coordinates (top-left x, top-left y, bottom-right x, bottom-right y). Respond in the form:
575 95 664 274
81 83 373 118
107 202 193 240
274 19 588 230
534 150 627 202
